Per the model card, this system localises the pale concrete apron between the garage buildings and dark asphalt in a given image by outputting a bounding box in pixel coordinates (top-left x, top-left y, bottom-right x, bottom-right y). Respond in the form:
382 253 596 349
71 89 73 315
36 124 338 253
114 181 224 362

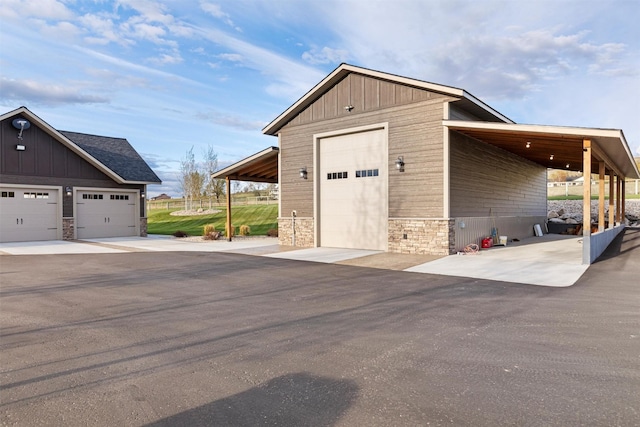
0 235 588 287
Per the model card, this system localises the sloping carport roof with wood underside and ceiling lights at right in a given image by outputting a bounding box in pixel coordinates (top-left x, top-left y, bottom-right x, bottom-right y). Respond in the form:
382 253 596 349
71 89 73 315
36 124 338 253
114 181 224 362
442 120 640 179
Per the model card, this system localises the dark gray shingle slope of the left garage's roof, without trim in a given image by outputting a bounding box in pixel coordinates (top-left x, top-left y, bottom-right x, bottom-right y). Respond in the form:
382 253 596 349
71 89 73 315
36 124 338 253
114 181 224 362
59 131 162 183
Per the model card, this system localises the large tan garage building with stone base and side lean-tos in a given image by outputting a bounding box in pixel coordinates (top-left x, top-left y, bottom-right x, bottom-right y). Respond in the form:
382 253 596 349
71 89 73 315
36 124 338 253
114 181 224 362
213 64 639 263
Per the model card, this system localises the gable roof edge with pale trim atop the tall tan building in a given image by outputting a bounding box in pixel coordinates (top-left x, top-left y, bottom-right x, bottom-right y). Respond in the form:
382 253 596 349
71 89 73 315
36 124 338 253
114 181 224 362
262 63 513 136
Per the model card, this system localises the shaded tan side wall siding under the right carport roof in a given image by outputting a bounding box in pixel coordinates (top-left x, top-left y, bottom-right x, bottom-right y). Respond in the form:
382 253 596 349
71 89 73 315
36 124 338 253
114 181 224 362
449 131 547 217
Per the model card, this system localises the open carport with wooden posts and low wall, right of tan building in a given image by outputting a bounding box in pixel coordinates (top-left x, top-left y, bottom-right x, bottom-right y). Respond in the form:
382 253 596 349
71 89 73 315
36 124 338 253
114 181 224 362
442 120 640 264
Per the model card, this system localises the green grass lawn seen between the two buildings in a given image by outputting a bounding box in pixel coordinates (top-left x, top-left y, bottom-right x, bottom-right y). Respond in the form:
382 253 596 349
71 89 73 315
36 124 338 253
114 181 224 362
147 205 278 236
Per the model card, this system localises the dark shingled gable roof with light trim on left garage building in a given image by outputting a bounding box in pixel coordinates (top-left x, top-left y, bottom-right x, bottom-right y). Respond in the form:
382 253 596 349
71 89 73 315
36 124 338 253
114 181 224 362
0 106 162 184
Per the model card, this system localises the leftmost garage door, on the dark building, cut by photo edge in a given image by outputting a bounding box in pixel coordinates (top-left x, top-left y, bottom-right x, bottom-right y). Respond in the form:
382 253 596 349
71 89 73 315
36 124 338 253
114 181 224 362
0 186 62 242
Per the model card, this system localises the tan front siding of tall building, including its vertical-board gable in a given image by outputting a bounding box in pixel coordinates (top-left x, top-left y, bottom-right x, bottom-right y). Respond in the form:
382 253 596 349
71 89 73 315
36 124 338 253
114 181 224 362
280 85 455 222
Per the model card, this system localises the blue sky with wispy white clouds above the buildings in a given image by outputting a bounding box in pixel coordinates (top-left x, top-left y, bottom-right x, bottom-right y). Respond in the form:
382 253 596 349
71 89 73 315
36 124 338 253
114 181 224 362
0 0 640 196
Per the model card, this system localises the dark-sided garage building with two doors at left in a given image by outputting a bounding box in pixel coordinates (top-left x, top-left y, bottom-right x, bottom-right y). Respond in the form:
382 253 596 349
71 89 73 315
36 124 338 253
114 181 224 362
0 107 161 242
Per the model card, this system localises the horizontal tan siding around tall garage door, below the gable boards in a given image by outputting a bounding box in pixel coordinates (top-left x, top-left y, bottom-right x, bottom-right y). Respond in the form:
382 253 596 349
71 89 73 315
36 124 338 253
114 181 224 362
280 95 456 218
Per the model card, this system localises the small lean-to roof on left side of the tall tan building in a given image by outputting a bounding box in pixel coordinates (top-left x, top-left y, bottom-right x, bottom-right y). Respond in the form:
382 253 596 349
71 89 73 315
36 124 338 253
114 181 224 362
211 147 280 183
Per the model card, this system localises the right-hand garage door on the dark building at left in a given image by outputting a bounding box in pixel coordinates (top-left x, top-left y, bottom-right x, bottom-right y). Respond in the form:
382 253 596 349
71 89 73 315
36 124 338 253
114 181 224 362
76 190 137 239
